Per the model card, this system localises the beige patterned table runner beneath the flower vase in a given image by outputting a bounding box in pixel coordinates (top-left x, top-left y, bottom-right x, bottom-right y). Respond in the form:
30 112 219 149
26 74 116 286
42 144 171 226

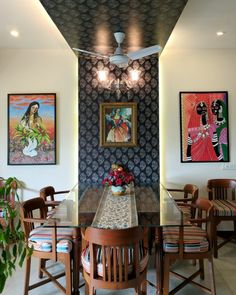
92 186 138 229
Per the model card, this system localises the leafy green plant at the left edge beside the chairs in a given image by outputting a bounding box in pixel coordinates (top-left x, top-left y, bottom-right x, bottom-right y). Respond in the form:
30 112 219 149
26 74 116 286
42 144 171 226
0 177 30 293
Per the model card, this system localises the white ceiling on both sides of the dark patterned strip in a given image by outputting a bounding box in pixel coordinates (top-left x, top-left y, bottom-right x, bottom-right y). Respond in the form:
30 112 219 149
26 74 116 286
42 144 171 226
0 0 236 49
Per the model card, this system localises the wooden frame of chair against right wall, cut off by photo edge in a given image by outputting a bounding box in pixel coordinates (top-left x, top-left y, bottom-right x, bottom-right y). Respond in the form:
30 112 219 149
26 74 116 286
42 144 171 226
207 179 236 258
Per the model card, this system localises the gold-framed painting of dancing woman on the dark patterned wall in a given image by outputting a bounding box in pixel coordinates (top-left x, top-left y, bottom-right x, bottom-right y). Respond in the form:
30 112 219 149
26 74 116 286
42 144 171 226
100 102 137 147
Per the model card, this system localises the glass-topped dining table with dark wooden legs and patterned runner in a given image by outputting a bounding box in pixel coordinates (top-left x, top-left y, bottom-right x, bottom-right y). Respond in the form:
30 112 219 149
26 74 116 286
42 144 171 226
43 184 184 295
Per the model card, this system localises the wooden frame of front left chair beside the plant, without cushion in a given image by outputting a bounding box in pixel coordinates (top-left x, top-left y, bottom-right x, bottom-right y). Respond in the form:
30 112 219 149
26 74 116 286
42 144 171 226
20 197 72 295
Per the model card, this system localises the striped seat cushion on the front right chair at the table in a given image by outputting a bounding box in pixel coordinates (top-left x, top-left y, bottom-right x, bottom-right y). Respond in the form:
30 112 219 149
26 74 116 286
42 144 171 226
163 226 209 253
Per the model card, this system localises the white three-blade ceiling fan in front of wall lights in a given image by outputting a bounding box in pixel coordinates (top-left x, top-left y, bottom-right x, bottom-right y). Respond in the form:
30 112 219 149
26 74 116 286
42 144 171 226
72 32 162 68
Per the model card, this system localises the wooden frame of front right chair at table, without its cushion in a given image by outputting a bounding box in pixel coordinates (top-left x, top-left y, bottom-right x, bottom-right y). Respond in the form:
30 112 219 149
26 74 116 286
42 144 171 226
158 198 216 295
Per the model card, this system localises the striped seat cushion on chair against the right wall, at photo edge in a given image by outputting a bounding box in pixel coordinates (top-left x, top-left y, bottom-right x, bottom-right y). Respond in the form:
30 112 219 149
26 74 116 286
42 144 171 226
211 200 236 216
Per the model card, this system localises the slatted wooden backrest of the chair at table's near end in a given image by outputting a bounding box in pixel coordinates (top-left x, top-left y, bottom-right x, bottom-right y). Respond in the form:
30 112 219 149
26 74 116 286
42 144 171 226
84 227 147 283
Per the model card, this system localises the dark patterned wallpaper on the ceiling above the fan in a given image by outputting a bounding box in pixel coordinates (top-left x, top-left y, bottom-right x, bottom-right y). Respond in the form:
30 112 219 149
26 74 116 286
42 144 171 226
40 0 188 54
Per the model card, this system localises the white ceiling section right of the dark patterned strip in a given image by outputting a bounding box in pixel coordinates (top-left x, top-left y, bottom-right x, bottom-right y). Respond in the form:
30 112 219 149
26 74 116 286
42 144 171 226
165 0 236 49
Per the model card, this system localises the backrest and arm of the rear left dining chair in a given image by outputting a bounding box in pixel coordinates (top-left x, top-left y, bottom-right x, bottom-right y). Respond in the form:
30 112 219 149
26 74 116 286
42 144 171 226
39 186 70 214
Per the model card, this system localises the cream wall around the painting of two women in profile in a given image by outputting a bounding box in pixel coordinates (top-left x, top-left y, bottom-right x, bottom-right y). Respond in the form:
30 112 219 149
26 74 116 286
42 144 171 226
160 49 236 196
